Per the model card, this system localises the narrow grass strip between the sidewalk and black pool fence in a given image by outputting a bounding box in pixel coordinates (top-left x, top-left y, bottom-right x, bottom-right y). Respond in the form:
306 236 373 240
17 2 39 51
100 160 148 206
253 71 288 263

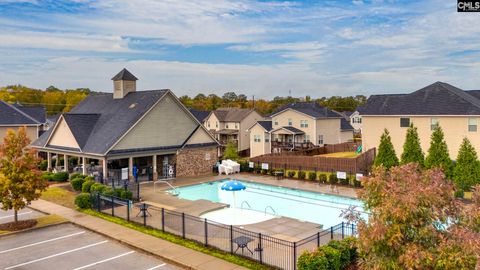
80 209 274 270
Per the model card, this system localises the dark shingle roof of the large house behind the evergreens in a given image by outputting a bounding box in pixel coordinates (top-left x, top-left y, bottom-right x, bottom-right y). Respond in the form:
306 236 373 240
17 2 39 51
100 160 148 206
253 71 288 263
358 82 480 115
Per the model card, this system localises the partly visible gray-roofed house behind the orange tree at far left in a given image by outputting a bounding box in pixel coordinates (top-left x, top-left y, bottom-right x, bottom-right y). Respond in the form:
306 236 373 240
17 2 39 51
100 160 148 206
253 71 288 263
0 100 46 142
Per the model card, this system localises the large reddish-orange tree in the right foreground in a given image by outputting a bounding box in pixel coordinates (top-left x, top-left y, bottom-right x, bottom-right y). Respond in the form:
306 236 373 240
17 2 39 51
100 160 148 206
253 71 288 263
358 163 480 269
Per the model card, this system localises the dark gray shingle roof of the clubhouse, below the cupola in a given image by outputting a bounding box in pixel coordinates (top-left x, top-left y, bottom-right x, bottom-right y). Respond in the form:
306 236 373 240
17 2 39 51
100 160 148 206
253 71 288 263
32 90 168 155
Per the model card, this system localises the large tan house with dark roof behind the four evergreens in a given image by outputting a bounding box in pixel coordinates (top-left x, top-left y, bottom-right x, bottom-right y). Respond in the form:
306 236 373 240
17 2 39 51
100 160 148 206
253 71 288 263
360 82 480 159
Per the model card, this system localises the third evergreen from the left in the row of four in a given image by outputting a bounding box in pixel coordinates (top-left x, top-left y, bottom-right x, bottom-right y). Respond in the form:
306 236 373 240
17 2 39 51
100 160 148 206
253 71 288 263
425 126 453 179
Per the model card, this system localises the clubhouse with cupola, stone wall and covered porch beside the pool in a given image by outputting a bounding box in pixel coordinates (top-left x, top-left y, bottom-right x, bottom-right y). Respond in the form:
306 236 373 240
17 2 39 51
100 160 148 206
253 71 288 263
31 69 219 180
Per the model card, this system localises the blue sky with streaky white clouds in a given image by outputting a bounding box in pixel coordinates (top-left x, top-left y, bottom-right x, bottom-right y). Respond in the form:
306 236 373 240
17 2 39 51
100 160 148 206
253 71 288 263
0 0 480 98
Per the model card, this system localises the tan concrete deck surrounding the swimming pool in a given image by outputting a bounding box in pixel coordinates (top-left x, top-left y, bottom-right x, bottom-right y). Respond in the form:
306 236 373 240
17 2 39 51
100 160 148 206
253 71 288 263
140 173 357 241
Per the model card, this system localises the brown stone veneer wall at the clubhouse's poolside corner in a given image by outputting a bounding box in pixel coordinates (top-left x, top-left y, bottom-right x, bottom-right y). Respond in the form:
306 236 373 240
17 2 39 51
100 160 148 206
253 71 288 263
177 147 218 177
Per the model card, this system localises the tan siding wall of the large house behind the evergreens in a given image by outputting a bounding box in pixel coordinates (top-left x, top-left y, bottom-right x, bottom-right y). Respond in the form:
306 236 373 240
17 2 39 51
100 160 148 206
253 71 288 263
362 116 480 159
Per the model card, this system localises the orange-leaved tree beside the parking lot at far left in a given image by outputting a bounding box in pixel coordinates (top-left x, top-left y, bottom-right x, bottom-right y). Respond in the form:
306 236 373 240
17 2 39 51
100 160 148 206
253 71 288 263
0 127 47 222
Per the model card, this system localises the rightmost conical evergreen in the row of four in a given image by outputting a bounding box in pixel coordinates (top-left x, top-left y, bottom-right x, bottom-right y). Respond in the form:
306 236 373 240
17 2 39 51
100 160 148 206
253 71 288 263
453 138 480 191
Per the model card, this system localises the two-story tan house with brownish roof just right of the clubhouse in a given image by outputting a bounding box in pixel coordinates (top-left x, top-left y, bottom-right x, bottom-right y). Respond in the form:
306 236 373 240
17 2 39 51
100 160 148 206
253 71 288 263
204 108 263 152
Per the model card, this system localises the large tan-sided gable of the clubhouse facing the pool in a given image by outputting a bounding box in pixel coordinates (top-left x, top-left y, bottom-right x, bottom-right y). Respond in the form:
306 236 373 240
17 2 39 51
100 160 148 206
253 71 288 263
114 95 197 150
